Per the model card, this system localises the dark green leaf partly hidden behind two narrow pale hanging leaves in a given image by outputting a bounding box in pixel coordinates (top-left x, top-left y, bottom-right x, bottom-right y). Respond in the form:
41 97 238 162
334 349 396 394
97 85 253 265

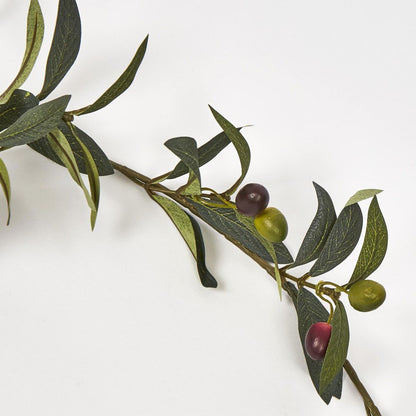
29 120 114 176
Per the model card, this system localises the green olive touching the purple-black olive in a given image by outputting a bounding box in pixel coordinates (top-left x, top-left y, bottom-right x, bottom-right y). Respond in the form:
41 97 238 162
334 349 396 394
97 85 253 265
254 207 287 243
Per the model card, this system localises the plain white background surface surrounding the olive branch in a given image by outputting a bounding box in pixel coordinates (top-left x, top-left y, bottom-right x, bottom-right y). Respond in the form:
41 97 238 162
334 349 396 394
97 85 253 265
0 0 416 416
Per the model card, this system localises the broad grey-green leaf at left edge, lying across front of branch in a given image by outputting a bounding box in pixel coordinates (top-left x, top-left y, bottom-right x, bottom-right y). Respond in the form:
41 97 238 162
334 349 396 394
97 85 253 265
0 95 71 147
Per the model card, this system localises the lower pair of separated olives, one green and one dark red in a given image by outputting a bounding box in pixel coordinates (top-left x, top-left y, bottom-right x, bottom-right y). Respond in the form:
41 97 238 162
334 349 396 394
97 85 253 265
305 280 386 360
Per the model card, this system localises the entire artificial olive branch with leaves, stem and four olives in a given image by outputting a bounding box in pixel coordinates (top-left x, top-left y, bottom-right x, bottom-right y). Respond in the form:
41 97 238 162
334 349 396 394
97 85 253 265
0 0 387 416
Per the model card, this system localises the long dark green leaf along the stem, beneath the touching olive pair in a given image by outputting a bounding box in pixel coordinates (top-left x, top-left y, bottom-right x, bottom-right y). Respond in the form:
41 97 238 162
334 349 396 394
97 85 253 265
188 199 293 264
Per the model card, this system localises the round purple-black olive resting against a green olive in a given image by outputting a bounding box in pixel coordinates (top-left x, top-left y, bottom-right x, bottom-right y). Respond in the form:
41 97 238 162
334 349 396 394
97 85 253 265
235 183 269 217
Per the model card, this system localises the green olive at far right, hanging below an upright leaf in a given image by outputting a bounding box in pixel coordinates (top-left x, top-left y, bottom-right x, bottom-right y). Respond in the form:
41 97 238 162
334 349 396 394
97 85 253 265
348 280 386 312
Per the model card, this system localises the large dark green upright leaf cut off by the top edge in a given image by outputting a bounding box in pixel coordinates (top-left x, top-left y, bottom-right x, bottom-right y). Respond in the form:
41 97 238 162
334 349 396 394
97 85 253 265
38 0 81 100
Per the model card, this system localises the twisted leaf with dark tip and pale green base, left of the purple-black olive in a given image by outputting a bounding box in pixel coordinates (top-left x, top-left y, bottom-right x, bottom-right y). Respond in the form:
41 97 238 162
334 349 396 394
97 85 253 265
165 137 201 195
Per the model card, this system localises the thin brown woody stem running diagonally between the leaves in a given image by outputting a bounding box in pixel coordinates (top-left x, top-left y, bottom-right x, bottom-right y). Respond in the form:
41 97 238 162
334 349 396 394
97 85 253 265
111 162 381 416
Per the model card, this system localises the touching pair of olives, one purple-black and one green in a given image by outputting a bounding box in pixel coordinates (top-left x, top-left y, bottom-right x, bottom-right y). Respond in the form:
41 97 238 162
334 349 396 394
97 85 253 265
235 183 288 243
